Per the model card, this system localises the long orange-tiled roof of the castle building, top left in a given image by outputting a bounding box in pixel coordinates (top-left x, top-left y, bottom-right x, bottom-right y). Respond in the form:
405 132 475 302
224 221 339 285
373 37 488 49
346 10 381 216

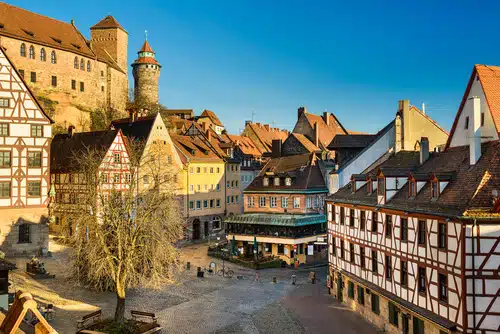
0 2 94 58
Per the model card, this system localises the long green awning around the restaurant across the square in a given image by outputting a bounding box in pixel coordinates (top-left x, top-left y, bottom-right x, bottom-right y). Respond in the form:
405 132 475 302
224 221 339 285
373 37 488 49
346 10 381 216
224 213 326 226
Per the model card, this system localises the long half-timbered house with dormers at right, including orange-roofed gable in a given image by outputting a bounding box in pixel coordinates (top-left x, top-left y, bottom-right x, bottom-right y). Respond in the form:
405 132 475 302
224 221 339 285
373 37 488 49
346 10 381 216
327 65 500 334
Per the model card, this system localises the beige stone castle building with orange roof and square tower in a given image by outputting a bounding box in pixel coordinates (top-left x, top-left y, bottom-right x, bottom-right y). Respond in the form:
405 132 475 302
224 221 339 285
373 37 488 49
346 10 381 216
0 3 128 129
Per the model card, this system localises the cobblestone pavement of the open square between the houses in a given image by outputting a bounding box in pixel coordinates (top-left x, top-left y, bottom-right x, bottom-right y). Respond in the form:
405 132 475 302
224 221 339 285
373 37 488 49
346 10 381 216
11 239 375 334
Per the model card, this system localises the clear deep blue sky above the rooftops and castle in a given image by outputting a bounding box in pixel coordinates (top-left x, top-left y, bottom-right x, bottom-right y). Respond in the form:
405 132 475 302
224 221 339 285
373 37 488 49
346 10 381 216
9 0 500 133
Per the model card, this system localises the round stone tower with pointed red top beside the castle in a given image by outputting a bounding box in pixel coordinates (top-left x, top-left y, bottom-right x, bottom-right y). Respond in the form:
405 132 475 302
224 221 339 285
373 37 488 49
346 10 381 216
132 40 161 105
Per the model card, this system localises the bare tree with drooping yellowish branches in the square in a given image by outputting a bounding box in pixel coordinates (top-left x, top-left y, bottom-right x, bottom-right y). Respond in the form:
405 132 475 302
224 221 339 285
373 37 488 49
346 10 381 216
58 136 183 323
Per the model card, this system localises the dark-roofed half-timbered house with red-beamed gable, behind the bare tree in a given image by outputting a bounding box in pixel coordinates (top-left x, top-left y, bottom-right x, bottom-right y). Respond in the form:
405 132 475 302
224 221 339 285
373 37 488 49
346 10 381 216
50 127 133 235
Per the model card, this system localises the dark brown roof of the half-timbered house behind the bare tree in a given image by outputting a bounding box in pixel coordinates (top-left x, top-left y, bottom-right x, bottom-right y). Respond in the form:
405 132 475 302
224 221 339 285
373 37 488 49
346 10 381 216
50 130 121 173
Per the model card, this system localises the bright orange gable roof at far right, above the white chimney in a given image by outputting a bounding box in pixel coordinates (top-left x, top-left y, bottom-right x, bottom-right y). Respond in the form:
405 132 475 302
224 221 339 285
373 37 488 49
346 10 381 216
446 65 500 148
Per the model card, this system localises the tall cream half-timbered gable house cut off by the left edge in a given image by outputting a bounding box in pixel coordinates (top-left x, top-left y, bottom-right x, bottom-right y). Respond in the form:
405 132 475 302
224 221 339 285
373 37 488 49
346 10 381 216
0 48 52 254
